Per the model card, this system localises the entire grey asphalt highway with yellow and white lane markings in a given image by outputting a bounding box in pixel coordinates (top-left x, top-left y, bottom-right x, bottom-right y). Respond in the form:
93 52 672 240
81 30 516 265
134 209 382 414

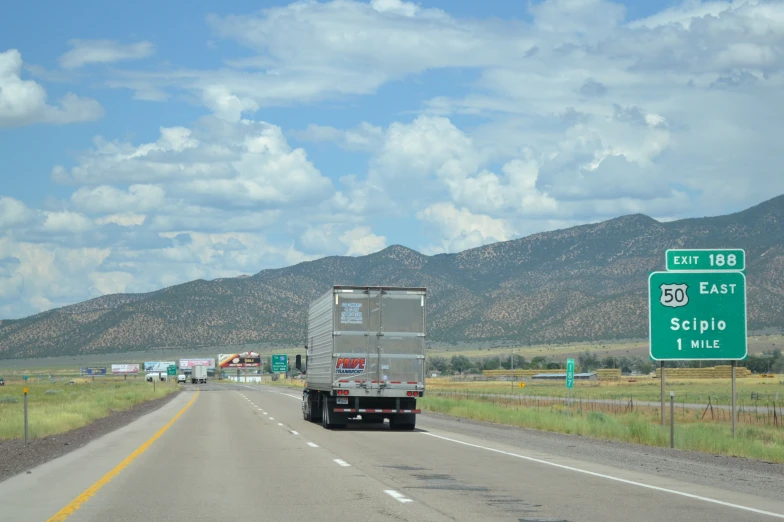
0 384 784 522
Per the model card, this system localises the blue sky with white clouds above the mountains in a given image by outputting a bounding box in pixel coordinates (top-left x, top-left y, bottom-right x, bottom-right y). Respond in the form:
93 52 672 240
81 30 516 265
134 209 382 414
0 0 784 318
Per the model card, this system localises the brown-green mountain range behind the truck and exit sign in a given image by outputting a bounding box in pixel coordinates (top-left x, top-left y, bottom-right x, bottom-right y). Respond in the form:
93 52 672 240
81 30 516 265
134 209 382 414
0 196 784 358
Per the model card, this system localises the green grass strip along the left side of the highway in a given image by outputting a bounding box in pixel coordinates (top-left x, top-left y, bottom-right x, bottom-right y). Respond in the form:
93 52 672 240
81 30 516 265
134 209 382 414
0 378 178 440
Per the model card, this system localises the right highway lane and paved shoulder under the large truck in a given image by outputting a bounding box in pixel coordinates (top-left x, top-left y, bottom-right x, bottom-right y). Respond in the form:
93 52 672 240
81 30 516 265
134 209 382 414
246 386 784 522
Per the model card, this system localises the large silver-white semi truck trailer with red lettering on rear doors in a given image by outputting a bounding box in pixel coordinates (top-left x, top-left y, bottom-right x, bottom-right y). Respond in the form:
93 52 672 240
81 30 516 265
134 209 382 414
296 286 427 430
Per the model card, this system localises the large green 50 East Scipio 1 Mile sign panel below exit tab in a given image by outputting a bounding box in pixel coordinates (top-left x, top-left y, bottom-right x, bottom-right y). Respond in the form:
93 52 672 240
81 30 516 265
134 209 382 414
648 271 748 361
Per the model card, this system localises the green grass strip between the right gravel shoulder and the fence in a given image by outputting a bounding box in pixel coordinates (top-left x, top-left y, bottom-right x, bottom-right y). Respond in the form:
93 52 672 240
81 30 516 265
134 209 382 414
418 397 784 463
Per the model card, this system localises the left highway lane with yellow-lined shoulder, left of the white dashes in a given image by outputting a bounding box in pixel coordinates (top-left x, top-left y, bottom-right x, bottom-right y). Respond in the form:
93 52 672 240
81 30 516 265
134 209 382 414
0 385 449 522
